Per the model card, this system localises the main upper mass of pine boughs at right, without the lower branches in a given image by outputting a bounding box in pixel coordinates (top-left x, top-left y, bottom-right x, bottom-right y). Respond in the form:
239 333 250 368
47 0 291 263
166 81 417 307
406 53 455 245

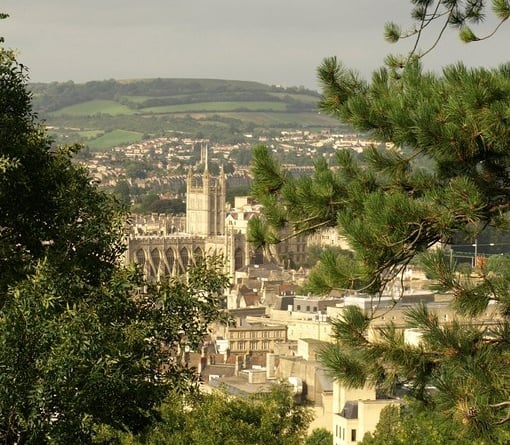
252 60 510 288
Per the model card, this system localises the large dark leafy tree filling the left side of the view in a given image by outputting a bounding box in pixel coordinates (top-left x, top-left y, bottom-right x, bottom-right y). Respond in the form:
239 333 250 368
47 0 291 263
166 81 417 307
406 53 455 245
0 40 228 445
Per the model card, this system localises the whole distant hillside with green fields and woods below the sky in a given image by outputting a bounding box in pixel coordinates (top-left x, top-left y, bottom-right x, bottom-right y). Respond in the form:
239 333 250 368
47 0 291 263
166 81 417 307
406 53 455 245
30 79 339 149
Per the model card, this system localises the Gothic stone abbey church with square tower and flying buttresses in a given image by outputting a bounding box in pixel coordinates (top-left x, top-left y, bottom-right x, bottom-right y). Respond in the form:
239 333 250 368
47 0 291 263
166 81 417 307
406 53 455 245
126 147 255 280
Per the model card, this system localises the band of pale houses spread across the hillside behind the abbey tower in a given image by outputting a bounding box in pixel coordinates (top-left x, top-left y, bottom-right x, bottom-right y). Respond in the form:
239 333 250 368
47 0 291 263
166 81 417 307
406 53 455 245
76 130 373 192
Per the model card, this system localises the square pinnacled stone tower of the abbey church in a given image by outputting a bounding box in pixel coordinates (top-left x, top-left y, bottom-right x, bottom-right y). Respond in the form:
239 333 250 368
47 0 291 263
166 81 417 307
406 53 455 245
186 145 226 236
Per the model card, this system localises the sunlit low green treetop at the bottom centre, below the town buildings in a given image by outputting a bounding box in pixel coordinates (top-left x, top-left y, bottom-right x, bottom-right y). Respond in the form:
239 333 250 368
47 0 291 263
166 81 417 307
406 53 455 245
108 386 311 445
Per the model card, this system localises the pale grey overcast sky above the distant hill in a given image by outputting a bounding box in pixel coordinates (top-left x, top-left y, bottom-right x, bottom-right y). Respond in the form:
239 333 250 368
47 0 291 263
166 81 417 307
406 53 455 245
0 0 510 90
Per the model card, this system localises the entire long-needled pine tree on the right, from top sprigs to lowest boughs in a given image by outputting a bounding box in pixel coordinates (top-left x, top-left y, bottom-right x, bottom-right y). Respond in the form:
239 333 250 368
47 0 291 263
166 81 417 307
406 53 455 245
250 1 510 443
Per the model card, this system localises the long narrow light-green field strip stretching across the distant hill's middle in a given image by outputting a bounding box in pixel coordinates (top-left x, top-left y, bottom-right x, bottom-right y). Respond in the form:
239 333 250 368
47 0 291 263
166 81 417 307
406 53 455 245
140 101 287 114
